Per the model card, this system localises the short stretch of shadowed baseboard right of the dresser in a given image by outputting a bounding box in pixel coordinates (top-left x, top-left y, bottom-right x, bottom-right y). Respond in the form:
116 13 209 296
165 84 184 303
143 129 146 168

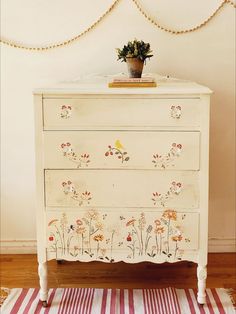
208 238 236 253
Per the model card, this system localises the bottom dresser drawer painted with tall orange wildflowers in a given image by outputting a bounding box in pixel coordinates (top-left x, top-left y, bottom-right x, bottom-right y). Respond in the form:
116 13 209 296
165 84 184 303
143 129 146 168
47 208 199 263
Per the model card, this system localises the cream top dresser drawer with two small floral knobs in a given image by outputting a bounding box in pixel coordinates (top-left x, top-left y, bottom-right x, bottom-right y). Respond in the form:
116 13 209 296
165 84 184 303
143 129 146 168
43 98 200 130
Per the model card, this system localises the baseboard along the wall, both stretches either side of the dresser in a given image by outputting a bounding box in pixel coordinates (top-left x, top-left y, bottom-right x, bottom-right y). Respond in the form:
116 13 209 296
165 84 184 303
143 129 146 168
0 238 236 254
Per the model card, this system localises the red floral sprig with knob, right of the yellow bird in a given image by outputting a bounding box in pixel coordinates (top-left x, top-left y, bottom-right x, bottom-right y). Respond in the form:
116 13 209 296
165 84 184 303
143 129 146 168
152 143 183 169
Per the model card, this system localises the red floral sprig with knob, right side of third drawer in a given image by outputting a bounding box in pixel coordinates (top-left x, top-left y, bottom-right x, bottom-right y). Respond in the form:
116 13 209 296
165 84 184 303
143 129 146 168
152 181 183 207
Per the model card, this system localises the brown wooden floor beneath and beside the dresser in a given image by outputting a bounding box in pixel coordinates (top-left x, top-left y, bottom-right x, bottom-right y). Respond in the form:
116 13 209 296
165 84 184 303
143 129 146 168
0 253 236 289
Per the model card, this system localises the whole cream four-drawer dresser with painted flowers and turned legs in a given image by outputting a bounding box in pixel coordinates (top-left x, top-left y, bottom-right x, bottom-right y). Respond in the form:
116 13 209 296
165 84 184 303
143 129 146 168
34 79 211 306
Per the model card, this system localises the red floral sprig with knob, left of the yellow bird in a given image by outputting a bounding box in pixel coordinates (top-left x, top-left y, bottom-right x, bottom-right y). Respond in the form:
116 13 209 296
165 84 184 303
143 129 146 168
61 142 90 168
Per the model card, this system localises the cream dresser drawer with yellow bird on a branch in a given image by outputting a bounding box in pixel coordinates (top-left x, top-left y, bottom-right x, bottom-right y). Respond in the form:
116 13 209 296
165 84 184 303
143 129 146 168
44 131 200 170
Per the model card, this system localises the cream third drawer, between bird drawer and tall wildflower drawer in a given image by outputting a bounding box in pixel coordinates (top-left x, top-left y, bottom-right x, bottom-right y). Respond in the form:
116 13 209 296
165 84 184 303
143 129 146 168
45 169 199 209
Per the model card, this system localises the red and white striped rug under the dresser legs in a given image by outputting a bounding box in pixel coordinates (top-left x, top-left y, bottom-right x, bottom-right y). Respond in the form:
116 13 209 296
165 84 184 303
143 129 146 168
0 288 235 314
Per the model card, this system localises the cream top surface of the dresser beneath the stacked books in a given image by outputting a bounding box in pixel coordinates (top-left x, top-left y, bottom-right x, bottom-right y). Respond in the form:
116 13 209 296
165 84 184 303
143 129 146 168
34 74 212 95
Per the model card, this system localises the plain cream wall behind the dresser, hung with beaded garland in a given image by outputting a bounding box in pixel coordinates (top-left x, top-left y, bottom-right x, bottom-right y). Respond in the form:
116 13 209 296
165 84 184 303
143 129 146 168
1 0 235 252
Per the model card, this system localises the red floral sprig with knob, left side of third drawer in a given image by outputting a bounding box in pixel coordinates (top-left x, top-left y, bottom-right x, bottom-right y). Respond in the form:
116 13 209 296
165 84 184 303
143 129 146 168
62 181 92 206
